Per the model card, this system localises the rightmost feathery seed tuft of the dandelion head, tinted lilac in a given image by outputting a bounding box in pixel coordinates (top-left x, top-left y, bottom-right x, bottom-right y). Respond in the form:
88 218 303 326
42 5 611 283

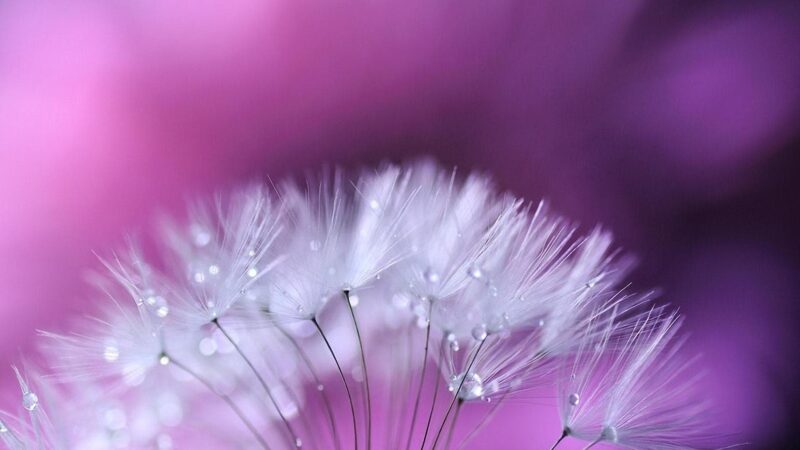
559 308 709 449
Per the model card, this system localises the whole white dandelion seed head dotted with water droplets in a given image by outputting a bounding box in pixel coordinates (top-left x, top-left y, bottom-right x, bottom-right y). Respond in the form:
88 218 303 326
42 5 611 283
0 160 728 450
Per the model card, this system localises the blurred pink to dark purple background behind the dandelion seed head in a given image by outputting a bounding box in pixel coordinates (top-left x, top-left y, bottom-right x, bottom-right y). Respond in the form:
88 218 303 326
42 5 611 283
0 0 800 448
